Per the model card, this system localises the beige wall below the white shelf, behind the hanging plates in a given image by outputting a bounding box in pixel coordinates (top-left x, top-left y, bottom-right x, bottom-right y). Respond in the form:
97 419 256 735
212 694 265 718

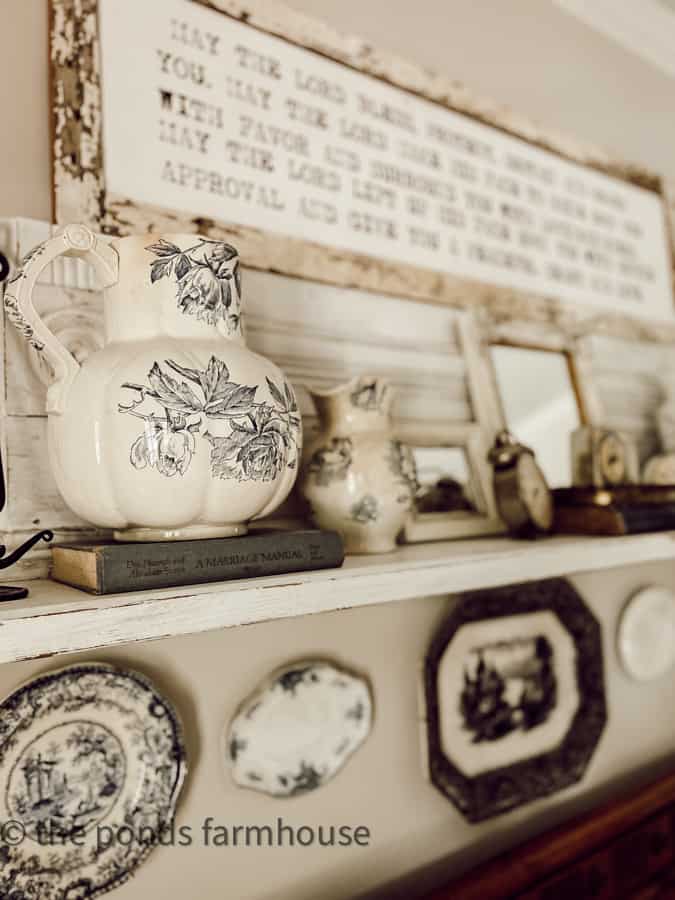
0 564 675 900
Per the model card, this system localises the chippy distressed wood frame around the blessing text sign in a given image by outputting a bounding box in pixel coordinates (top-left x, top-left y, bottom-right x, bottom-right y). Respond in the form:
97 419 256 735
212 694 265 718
50 0 675 342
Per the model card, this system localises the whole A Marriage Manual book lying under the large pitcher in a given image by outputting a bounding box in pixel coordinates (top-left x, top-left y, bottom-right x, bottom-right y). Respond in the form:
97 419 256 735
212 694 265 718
51 531 344 594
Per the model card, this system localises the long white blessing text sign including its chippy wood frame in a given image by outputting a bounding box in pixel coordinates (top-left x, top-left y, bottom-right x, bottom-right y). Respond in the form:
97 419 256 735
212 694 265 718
52 0 674 321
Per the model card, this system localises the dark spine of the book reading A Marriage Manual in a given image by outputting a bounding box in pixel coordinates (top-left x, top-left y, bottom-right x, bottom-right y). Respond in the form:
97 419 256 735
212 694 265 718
96 531 344 594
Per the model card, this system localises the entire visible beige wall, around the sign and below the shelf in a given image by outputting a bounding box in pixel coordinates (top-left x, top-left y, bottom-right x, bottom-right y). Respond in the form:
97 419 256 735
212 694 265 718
0 0 675 900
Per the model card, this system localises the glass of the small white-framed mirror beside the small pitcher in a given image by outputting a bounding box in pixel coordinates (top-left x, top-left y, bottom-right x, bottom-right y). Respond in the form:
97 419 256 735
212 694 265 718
409 447 476 514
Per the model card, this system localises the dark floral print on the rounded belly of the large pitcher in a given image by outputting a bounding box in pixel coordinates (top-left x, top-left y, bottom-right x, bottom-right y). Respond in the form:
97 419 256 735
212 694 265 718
118 356 300 481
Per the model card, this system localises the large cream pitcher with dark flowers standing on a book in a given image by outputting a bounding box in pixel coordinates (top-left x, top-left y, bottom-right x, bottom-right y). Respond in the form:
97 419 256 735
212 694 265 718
5 225 302 541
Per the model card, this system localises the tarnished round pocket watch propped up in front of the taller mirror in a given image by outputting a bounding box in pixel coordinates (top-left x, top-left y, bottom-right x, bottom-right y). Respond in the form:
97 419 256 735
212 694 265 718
488 430 553 537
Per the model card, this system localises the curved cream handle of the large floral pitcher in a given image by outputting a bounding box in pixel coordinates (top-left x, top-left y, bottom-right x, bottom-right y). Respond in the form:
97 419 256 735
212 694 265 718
5 225 119 415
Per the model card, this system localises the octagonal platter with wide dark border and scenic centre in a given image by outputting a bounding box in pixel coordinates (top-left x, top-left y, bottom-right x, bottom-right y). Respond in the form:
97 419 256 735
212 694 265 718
424 579 607 822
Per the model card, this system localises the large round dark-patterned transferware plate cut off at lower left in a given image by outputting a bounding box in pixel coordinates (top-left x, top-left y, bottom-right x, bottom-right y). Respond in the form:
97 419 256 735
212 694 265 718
0 663 186 900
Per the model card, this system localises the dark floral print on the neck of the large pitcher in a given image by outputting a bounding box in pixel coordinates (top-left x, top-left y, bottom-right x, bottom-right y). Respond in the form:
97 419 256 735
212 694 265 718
145 238 241 334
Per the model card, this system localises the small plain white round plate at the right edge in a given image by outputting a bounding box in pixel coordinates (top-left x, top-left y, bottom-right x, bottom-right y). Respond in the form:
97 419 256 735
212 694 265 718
618 587 675 681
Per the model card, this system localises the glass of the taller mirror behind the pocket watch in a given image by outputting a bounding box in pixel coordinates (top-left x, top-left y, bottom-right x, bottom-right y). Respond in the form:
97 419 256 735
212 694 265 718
490 346 581 488
